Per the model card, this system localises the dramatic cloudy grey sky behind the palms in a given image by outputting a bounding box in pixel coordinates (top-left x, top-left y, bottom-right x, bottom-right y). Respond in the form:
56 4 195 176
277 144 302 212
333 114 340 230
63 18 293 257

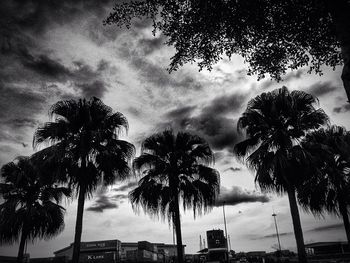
0 0 350 257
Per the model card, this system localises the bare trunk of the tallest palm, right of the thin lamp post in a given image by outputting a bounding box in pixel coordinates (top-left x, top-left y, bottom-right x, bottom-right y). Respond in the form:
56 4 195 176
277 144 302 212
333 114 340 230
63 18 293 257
287 187 307 263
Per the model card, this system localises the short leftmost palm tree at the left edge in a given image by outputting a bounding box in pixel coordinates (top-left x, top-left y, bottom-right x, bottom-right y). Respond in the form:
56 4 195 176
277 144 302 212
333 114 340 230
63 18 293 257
0 157 70 263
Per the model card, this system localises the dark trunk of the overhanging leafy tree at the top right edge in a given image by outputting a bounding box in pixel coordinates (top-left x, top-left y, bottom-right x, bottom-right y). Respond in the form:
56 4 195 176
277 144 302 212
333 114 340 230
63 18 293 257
326 0 350 102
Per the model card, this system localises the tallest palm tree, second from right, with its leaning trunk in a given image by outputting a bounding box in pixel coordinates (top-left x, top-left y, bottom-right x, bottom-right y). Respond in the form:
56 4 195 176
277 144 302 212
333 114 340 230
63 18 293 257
235 87 328 262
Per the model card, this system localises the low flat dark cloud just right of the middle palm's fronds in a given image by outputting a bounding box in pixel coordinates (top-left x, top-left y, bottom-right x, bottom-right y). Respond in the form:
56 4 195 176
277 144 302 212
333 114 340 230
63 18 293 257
215 186 270 206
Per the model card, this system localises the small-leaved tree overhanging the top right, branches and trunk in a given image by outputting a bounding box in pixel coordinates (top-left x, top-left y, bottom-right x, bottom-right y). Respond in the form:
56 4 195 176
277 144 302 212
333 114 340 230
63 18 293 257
104 0 350 100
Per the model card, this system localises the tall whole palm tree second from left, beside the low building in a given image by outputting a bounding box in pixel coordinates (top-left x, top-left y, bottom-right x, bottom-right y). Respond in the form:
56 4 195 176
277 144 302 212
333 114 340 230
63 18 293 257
33 97 134 263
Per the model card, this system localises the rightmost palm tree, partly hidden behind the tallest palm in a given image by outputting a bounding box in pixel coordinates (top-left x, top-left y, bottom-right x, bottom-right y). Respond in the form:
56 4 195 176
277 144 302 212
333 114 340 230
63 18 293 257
298 126 350 244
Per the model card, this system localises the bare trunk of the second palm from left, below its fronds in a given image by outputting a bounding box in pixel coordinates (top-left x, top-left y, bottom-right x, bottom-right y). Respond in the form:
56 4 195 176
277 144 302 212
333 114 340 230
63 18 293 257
72 185 85 263
